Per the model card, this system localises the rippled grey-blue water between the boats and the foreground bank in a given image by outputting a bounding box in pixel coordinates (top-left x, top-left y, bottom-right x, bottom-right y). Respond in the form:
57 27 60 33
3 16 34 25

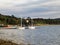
0 25 60 45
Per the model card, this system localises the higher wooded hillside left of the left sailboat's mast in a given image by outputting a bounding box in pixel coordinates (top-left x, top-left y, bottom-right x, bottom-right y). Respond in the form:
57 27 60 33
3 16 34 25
0 14 20 25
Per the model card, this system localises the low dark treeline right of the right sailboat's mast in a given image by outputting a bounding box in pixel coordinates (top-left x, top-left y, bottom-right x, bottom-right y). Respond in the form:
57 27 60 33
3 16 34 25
33 18 60 24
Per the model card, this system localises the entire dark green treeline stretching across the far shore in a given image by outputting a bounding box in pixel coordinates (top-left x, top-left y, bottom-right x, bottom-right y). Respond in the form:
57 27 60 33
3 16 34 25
0 14 60 25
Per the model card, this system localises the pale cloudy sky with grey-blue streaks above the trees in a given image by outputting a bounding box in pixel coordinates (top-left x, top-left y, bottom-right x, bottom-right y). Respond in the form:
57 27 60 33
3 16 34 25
0 0 60 18
